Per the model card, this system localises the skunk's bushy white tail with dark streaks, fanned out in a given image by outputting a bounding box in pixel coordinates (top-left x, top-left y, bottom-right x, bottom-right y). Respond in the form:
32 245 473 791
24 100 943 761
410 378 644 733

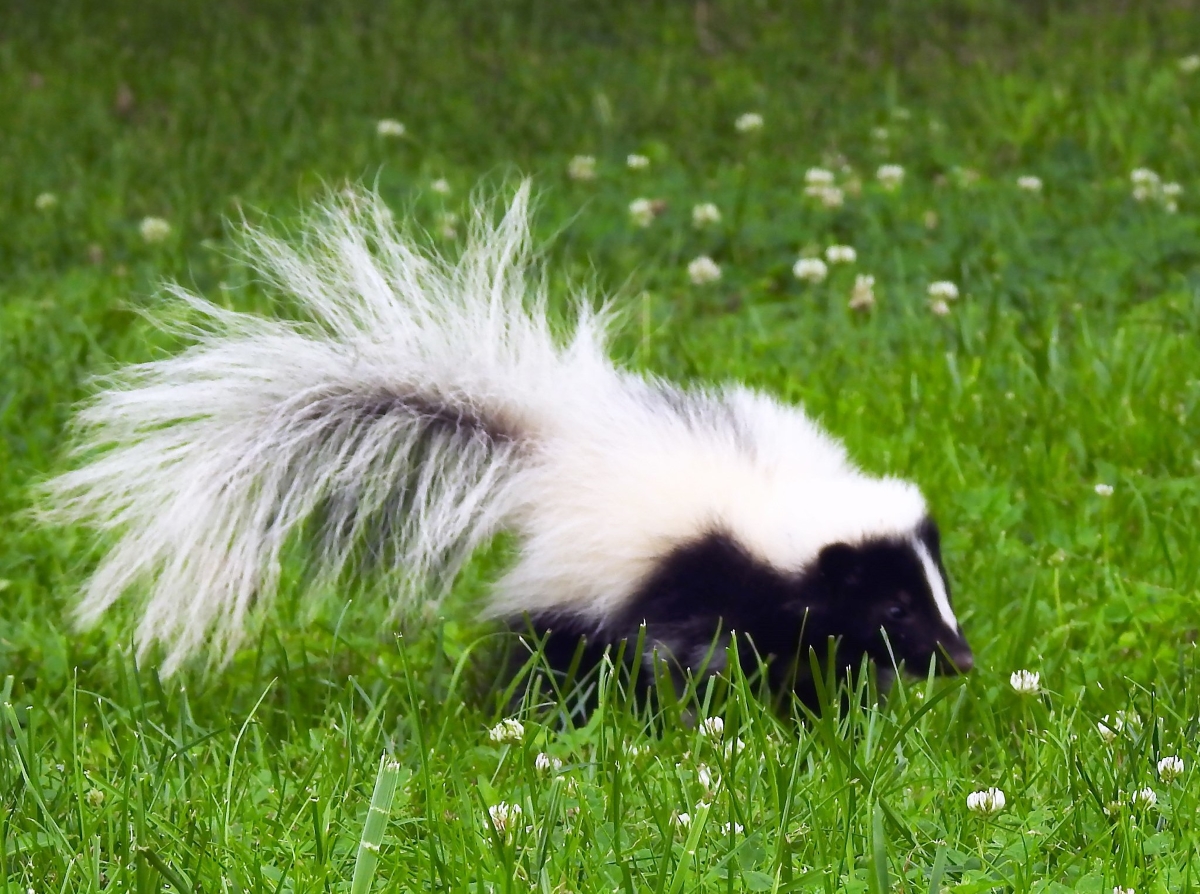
44 184 613 674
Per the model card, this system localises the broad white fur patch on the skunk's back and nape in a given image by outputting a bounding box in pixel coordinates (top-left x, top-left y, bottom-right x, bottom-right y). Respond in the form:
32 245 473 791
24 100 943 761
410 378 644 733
488 373 925 622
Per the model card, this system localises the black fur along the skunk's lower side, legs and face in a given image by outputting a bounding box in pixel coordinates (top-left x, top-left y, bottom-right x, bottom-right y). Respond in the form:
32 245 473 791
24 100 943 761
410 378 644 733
520 521 973 708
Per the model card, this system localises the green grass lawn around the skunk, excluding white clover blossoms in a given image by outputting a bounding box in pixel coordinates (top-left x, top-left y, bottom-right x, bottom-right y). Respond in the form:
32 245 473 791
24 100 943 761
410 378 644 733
7 0 1200 894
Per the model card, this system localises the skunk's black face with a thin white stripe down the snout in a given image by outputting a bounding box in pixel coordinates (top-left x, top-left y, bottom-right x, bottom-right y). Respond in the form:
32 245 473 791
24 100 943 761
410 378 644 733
805 521 974 674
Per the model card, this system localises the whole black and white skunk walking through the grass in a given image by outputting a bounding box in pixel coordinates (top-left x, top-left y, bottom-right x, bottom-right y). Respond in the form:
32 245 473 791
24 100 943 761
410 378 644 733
46 186 972 705
